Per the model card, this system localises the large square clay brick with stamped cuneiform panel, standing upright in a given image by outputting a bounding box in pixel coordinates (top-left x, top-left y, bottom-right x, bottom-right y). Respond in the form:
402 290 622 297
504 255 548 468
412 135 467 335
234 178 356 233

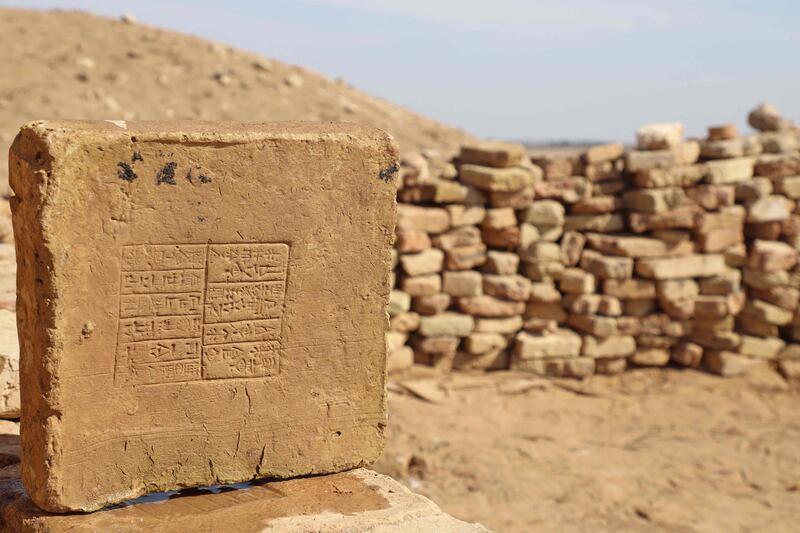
9 121 398 512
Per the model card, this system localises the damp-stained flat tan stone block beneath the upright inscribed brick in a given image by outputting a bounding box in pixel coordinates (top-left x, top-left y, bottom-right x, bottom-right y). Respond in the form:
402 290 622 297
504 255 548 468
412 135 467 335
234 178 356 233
0 468 488 533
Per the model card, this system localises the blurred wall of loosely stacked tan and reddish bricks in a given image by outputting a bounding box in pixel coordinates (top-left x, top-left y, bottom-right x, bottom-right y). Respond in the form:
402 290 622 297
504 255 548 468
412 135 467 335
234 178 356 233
389 106 800 377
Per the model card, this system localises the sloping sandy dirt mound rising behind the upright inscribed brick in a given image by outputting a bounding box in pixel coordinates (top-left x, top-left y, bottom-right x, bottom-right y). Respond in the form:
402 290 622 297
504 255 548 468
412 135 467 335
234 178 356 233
0 9 470 189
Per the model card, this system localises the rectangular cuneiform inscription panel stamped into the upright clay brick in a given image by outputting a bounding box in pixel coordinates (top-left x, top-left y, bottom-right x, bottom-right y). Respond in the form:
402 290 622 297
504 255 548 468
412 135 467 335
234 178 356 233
114 243 289 385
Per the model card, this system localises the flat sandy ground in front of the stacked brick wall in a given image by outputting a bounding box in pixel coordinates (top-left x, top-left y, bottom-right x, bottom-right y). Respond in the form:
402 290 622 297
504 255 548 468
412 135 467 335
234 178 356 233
377 369 800 532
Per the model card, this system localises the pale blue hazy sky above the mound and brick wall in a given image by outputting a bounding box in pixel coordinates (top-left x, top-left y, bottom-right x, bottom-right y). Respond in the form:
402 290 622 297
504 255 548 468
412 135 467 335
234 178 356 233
6 0 800 141
